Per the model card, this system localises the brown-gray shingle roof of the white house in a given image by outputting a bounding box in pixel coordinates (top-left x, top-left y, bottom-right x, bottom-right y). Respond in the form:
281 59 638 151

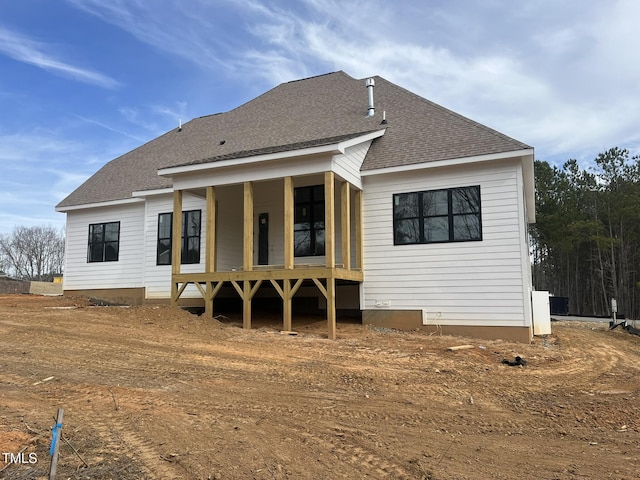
58 72 531 207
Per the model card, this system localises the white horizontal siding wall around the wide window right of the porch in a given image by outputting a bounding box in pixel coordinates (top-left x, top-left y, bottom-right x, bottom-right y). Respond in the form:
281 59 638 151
363 160 530 326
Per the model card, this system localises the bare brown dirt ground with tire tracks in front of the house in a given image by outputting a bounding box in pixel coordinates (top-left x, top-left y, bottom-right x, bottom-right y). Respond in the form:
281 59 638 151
0 295 640 480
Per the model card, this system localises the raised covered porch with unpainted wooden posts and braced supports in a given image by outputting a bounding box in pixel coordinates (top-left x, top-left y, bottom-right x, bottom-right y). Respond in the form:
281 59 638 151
171 170 364 339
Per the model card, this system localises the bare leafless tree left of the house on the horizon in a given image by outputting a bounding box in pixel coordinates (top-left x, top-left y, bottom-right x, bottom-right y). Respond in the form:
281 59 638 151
0 226 64 281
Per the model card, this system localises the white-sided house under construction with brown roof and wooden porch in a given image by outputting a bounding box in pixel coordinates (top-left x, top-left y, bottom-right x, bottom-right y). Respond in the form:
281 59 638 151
56 71 535 341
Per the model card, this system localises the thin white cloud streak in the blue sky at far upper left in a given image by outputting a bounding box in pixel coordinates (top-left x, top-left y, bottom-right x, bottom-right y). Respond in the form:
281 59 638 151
0 27 119 88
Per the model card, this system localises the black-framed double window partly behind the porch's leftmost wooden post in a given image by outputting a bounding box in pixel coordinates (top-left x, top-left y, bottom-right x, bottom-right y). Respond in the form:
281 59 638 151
156 210 201 265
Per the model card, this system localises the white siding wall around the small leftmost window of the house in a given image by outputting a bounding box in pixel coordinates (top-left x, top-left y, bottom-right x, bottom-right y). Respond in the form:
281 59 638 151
63 202 144 290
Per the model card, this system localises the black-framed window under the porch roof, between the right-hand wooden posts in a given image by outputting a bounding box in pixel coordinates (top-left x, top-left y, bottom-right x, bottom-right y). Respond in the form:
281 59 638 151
293 185 324 257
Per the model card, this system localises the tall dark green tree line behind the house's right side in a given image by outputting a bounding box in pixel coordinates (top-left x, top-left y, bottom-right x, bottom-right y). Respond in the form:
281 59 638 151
530 147 640 319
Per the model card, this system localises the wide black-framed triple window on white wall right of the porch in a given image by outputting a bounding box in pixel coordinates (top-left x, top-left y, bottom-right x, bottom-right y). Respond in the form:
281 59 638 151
393 185 482 245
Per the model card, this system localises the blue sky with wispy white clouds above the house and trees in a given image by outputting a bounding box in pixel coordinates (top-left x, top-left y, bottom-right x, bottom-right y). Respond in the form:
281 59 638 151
0 0 640 233
